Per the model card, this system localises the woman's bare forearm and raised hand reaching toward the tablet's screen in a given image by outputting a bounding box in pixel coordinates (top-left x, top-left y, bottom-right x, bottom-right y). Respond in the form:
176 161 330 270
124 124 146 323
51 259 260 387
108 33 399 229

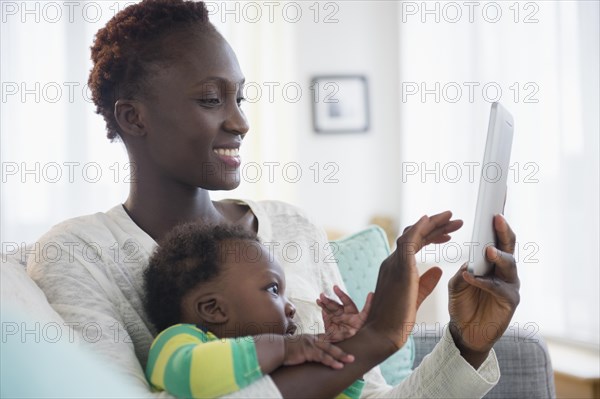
271 212 462 398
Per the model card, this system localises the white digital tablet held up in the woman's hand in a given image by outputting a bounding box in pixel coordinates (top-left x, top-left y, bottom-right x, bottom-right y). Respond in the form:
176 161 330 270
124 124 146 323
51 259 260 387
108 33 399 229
467 102 514 276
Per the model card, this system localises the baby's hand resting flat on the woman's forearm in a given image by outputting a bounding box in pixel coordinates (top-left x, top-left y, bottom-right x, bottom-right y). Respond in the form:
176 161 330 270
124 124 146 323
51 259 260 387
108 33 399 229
283 334 354 369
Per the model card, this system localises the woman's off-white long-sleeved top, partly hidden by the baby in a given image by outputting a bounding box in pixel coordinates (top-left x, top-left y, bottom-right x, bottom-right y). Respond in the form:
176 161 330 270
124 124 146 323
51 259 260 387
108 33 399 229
27 201 500 398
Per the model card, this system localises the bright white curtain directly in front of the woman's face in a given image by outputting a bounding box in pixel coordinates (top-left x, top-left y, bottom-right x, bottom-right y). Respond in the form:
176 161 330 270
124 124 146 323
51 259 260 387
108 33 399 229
207 1 298 202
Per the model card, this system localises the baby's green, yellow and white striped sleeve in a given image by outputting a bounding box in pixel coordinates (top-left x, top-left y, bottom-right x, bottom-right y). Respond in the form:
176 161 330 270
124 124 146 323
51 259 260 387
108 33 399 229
146 324 262 398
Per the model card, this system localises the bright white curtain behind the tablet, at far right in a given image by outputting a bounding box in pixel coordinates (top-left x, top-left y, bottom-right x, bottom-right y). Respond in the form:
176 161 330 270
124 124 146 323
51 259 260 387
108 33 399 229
399 1 600 346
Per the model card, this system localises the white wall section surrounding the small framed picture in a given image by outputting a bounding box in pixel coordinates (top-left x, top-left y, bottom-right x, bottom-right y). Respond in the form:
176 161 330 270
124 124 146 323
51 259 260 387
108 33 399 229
296 1 400 236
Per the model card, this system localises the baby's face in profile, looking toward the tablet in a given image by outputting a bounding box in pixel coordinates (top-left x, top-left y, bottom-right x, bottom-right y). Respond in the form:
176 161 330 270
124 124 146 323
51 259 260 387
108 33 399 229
219 241 296 336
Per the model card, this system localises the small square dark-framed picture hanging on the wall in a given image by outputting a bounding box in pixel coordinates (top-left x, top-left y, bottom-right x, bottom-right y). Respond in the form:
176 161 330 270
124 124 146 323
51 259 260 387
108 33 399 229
311 75 369 133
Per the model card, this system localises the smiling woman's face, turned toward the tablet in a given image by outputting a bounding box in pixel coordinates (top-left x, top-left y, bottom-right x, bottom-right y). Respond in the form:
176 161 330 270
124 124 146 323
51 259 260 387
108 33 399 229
135 34 249 190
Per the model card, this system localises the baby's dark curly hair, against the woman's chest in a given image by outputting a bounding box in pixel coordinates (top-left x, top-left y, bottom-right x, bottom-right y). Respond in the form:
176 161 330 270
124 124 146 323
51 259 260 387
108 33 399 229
144 223 259 332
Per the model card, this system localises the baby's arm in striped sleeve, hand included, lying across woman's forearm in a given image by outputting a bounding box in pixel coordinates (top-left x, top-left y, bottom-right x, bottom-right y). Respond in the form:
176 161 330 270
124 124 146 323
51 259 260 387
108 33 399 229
146 324 354 398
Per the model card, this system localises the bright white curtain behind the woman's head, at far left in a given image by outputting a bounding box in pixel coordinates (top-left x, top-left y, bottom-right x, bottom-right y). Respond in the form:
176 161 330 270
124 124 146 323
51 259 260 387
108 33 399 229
1 2 129 247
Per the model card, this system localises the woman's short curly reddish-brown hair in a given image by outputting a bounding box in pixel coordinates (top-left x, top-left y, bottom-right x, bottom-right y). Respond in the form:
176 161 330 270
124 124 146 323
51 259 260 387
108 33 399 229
88 0 219 140
